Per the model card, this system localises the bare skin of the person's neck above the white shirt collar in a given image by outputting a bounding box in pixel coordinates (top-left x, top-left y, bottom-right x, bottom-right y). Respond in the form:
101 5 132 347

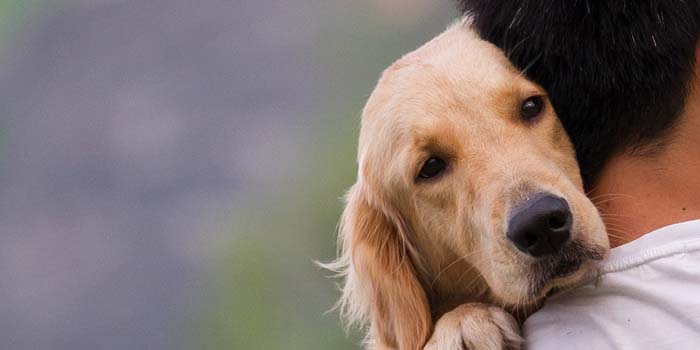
590 64 700 247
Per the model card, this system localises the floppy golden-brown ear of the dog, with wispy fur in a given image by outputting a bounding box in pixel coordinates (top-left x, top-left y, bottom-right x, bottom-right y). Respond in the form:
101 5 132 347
336 183 432 350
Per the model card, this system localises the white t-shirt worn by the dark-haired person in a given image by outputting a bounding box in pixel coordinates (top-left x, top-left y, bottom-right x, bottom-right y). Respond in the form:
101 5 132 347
523 220 700 350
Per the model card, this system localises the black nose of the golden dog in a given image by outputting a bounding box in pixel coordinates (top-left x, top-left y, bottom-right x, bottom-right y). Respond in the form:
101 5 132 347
507 193 572 257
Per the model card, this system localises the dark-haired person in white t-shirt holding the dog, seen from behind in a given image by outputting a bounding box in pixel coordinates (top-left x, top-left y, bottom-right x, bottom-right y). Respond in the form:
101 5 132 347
459 0 700 350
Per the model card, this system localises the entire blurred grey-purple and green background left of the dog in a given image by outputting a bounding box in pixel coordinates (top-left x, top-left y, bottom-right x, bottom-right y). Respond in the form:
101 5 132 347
0 0 457 350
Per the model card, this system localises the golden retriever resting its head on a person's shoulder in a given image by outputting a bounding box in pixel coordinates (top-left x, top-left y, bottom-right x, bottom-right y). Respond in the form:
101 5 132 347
326 17 609 350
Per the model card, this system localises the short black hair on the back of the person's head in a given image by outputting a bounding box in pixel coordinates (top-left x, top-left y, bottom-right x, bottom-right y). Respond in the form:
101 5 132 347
458 0 700 187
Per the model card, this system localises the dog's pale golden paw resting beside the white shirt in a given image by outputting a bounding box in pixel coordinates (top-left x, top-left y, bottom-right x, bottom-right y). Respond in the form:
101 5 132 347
423 303 522 350
